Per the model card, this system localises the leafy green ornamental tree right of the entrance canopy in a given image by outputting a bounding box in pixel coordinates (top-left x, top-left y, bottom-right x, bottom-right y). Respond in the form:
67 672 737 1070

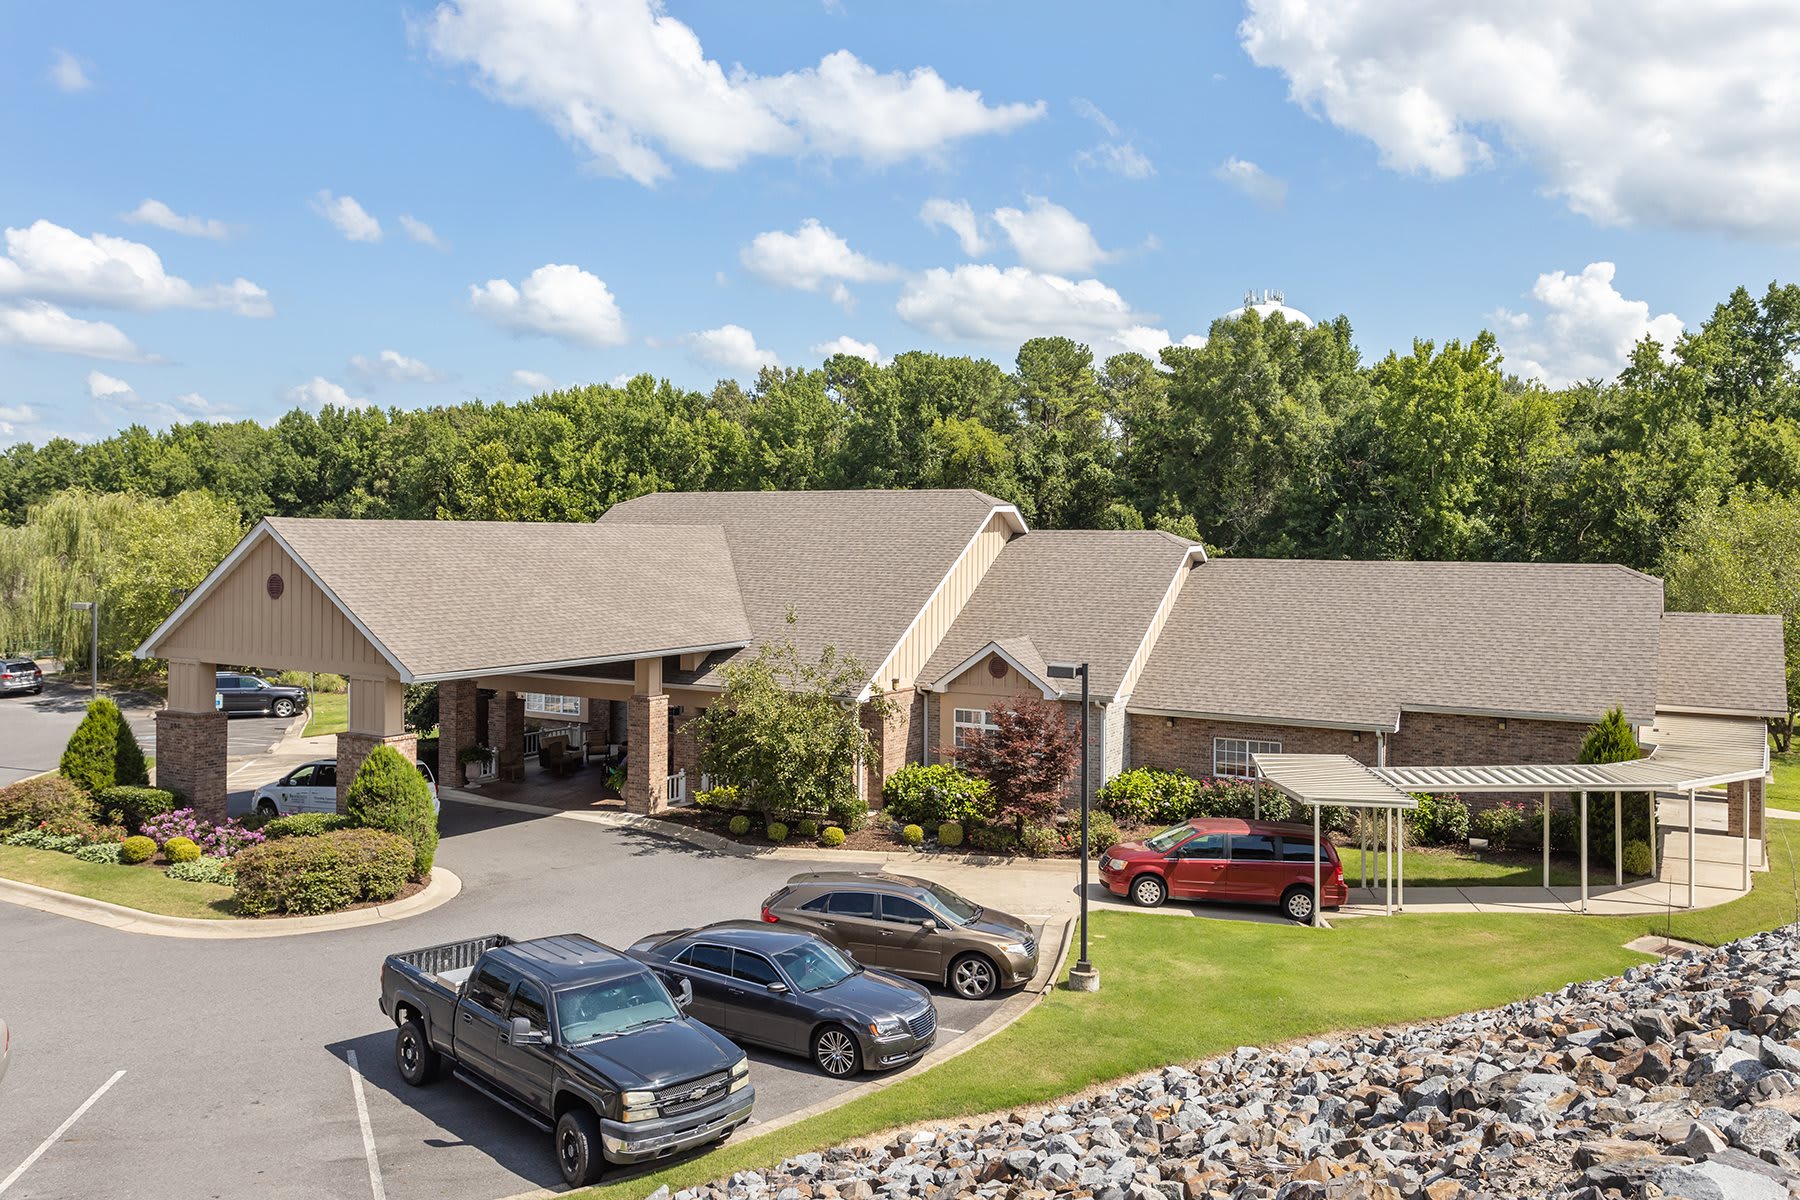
688 617 893 828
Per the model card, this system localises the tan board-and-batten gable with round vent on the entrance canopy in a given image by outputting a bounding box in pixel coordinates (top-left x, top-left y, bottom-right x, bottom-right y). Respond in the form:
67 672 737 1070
155 538 400 678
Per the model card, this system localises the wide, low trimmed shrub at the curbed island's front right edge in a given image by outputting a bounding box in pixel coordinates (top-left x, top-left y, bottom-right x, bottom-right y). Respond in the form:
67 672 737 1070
232 831 414 916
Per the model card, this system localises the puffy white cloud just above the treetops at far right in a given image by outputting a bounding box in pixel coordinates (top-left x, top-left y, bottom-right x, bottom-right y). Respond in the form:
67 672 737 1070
1494 263 1681 387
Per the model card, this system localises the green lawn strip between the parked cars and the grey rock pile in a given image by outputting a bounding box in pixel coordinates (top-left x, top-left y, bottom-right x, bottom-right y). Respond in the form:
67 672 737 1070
581 840 1796 1200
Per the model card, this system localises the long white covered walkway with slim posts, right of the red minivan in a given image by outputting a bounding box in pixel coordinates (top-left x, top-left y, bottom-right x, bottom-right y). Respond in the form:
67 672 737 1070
1255 712 1769 912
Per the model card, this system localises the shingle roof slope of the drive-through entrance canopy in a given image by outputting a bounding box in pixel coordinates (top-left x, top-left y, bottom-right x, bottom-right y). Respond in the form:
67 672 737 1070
266 516 751 678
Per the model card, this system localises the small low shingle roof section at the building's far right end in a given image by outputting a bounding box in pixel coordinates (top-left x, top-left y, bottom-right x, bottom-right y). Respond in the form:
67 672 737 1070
1656 612 1787 716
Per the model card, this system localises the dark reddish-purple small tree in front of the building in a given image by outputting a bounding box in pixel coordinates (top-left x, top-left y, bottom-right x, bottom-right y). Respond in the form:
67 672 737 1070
956 696 1080 835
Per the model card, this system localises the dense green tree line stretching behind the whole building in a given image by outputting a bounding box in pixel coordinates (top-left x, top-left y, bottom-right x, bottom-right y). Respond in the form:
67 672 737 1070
0 286 1800 570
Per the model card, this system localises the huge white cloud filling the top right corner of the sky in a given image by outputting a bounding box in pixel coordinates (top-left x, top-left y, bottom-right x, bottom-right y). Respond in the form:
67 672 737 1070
1238 0 1800 241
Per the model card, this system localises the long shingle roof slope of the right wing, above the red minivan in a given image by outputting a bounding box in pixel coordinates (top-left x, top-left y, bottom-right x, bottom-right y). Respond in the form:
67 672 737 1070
1130 558 1663 729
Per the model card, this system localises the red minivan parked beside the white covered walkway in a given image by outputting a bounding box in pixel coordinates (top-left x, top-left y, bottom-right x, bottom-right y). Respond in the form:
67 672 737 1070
1100 817 1350 921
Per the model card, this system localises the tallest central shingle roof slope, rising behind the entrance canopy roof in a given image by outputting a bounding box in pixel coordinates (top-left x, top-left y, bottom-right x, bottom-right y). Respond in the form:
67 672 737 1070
601 489 1010 684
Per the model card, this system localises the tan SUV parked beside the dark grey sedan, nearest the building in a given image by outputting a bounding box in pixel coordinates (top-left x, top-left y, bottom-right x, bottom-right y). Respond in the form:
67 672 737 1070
763 871 1037 1000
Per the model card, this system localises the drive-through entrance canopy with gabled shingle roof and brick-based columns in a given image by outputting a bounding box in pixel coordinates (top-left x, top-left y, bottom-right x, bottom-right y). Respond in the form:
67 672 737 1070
137 518 751 819
